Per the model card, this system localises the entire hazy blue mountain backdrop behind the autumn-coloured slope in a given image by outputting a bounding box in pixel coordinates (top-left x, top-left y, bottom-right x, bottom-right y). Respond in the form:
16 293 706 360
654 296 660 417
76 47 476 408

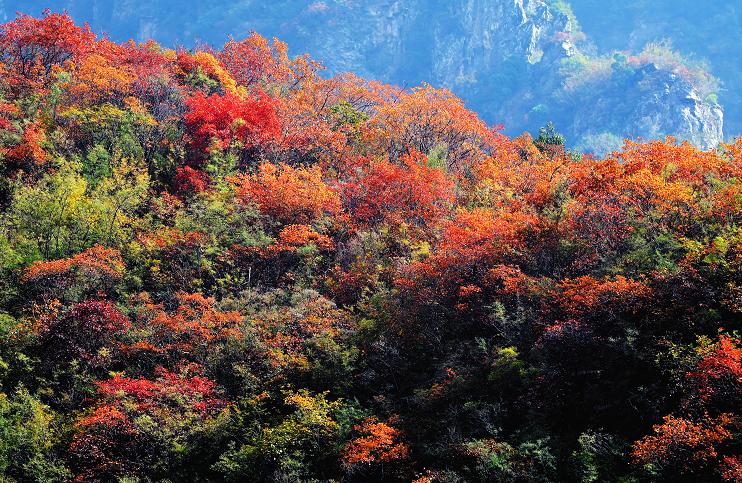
0 0 742 152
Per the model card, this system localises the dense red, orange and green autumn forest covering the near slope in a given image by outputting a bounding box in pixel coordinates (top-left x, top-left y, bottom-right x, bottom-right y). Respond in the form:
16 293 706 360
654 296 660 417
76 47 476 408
0 11 742 483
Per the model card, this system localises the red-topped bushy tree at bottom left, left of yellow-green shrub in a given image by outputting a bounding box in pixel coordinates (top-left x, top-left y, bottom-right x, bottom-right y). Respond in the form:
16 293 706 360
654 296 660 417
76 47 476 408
70 365 228 480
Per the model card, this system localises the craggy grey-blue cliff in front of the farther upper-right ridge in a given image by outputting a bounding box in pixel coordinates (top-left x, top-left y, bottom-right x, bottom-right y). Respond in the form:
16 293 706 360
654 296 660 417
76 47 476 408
0 0 723 151
